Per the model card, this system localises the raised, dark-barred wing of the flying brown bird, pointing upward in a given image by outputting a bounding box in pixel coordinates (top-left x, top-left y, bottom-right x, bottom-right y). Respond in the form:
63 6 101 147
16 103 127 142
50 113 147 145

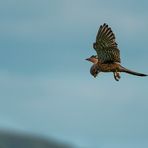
93 24 120 63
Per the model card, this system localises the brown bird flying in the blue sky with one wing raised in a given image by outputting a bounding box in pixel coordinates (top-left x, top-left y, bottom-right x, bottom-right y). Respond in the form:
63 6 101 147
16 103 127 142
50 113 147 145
86 23 148 81
